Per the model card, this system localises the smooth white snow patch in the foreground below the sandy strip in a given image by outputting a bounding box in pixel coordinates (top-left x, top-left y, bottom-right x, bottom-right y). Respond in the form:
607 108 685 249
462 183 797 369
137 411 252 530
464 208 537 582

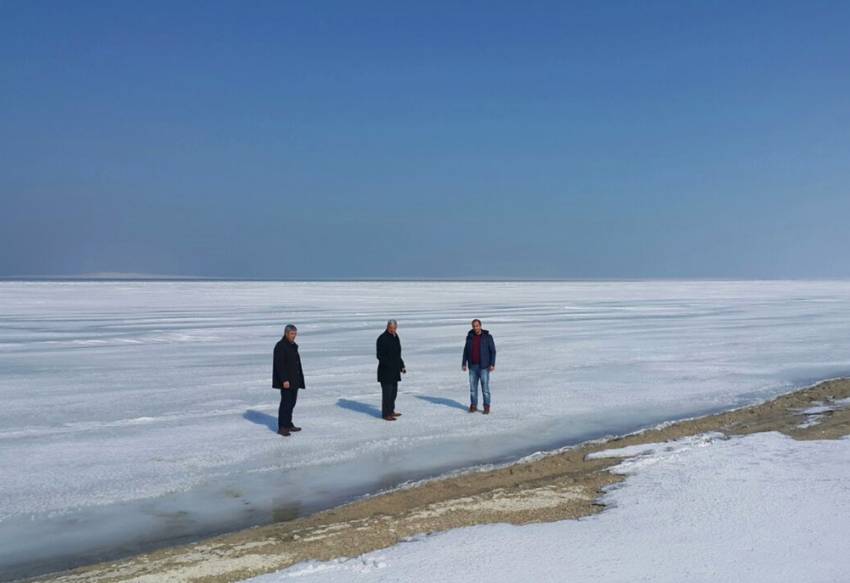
250 433 850 583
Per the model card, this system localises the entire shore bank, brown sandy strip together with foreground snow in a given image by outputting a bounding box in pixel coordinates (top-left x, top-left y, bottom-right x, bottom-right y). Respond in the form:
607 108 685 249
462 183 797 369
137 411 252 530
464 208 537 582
34 380 850 583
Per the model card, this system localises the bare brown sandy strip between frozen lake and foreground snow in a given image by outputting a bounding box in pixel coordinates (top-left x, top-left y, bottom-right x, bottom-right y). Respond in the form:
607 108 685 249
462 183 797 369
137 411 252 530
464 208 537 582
29 380 850 583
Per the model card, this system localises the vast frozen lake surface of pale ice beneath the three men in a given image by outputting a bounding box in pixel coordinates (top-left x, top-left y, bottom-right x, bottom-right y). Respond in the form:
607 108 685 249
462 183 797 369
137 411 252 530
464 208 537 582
0 281 850 579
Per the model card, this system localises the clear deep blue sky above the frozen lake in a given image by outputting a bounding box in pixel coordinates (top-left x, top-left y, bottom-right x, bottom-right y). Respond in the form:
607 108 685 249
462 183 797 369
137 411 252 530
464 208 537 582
0 0 850 278
